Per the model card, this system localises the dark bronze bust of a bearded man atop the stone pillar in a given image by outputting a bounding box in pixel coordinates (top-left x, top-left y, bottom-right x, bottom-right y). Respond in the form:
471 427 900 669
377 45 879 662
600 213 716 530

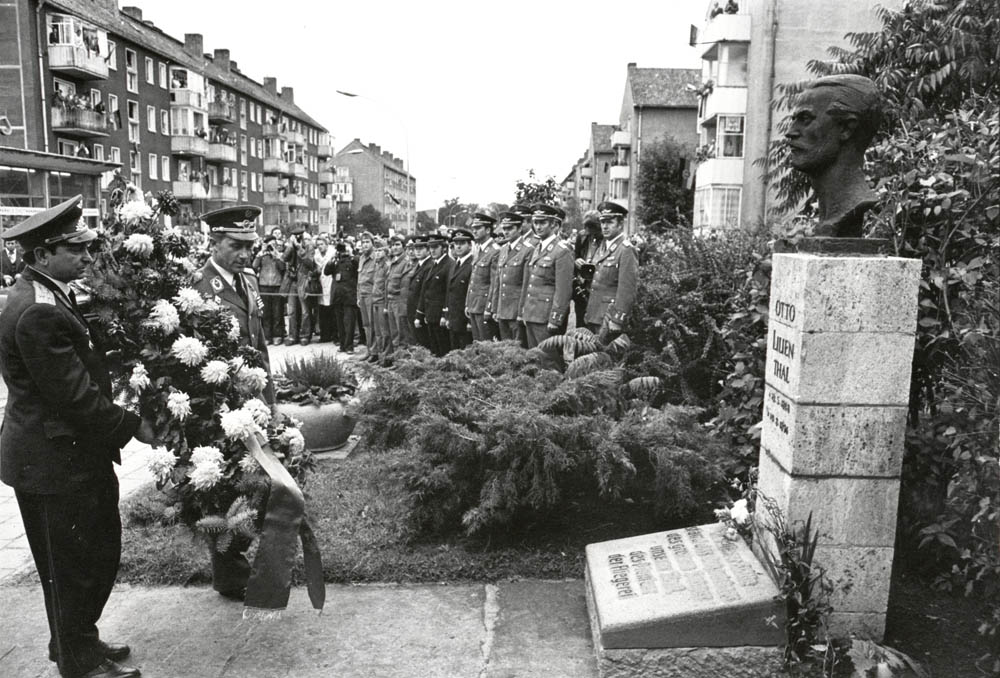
785 75 882 238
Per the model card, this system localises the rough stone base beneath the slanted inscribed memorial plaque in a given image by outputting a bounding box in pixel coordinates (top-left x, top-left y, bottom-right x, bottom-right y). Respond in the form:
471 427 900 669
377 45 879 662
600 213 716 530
586 581 787 678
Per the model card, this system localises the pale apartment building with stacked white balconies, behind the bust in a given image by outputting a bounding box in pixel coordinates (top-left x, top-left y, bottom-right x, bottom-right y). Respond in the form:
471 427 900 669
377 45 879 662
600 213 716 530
693 0 899 233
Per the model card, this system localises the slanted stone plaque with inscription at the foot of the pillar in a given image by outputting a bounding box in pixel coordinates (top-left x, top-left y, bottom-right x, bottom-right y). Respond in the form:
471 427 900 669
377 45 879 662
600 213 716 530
587 524 784 649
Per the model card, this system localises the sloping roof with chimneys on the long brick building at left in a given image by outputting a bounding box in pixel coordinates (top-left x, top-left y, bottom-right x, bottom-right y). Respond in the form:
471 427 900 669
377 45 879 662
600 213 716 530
48 0 329 132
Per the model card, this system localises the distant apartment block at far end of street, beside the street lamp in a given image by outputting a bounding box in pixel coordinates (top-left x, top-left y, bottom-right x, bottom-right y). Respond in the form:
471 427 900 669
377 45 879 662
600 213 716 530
333 139 417 235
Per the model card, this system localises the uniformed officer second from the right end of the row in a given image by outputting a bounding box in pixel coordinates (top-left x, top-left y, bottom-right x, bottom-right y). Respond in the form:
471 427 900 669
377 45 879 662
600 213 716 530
520 204 573 348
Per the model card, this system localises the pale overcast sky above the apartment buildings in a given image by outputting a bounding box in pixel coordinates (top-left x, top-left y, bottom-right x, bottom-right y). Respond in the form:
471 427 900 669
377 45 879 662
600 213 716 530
135 0 708 209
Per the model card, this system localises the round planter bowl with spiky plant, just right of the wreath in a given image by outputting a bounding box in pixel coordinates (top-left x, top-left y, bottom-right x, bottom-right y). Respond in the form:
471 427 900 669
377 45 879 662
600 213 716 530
274 354 358 453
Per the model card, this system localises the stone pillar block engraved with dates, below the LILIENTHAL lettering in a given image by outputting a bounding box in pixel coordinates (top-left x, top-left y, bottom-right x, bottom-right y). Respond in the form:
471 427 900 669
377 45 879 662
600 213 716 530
761 386 906 477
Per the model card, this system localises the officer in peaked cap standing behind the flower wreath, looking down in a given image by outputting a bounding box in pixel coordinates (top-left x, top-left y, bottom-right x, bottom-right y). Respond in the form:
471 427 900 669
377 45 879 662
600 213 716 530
191 205 274 600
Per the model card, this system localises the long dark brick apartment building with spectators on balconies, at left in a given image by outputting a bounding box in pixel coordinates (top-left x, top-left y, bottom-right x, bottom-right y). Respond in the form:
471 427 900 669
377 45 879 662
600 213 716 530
0 0 335 235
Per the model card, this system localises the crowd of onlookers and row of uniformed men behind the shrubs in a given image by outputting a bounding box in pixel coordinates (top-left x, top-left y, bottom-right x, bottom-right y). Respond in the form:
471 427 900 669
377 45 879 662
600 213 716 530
252 202 638 362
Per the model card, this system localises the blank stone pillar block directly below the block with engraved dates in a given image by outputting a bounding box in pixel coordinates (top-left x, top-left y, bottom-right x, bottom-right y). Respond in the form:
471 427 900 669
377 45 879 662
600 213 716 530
757 449 899 547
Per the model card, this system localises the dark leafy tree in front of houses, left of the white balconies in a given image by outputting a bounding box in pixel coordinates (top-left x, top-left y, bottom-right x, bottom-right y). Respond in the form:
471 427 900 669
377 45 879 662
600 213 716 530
635 136 694 231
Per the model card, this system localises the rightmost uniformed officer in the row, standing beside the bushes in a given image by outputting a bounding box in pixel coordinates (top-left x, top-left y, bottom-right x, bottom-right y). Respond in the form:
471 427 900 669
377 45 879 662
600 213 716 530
584 201 639 342
